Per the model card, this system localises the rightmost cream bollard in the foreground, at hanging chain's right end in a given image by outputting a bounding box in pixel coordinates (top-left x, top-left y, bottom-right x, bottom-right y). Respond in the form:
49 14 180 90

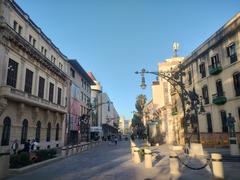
211 153 224 179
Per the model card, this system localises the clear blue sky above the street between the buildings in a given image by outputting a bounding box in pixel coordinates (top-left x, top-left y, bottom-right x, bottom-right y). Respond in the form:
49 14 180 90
16 0 240 118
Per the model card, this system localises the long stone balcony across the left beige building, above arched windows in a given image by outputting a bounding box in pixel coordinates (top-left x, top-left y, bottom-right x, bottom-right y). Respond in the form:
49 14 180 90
0 86 67 113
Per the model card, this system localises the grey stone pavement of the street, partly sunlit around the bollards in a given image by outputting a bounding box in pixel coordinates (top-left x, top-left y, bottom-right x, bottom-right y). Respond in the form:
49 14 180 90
6 141 240 180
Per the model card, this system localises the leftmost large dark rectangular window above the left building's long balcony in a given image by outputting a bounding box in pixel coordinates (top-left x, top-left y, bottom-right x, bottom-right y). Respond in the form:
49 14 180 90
7 59 18 88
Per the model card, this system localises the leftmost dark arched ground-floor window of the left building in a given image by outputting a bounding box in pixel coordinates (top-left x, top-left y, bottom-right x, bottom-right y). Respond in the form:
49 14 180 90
1 117 11 146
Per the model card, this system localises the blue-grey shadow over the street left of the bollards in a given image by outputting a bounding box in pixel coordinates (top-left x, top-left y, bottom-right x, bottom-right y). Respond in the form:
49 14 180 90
6 143 142 180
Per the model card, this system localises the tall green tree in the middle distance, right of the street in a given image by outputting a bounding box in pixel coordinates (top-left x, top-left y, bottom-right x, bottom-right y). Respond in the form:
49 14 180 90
132 94 147 138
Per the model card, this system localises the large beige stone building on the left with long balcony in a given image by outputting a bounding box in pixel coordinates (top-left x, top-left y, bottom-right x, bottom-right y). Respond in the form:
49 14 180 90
0 0 68 151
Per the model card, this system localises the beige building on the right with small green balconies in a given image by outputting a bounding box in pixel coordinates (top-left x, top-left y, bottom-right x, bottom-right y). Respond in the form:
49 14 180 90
180 13 240 146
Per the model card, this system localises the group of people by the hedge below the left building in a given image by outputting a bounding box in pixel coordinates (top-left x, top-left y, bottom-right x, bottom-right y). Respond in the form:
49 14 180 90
11 139 39 154
